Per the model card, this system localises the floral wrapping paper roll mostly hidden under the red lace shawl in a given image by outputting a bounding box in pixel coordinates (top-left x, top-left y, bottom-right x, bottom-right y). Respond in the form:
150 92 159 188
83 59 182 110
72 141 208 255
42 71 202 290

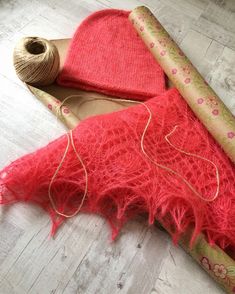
28 81 235 293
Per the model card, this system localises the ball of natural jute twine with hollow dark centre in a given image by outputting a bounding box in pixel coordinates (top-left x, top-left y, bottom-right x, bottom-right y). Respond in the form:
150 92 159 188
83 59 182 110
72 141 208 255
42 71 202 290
13 37 60 86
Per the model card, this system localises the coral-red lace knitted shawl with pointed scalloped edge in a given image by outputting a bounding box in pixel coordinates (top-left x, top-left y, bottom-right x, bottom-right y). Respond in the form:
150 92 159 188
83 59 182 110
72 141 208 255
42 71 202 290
0 89 235 251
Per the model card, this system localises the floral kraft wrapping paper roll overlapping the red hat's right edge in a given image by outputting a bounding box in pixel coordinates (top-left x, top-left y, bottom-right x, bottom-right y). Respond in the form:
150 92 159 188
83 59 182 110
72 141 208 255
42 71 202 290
129 6 235 163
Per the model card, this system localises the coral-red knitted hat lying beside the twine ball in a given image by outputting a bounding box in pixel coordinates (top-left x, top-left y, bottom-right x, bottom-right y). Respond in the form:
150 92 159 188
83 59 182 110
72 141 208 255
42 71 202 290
57 9 165 100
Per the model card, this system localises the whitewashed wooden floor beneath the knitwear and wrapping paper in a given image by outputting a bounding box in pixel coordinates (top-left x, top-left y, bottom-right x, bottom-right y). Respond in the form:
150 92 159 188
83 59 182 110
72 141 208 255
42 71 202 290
0 0 235 294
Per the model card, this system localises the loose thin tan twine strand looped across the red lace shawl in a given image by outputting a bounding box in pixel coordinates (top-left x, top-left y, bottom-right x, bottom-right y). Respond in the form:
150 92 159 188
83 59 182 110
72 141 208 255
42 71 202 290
48 94 220 218
